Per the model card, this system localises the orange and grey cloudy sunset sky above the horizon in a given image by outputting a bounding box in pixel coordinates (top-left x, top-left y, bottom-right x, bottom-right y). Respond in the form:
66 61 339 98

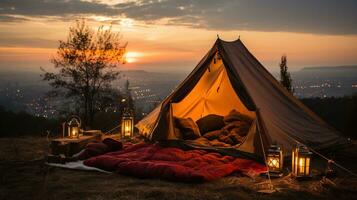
0 0 357 72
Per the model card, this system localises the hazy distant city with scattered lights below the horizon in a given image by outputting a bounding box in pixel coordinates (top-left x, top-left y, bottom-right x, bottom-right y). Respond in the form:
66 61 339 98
0 66 357 118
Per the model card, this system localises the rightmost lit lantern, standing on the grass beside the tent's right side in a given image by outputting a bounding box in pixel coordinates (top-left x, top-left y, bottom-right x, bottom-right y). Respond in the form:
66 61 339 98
291 145 312 177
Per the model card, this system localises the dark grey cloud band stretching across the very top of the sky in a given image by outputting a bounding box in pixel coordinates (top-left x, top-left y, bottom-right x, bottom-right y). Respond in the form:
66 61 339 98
0 0 357 34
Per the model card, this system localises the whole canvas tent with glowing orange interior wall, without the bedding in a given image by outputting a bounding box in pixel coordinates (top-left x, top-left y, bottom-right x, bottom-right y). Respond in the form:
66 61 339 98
136 38 345 155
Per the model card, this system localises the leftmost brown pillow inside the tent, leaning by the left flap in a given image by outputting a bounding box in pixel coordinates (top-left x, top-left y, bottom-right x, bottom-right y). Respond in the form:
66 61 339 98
175 118 201 140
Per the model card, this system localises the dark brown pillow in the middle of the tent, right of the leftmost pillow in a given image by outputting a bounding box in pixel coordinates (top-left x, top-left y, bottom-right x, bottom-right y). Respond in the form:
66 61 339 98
196 114 225 135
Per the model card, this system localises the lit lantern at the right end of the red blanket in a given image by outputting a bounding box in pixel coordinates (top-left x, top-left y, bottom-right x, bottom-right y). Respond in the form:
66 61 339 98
267 145 283 173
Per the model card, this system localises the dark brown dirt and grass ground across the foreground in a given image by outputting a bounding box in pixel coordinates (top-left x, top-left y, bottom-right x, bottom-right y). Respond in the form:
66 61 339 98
0 137 357 200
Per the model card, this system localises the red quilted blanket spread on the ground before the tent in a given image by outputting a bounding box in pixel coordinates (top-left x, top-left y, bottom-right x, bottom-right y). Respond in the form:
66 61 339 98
84 143 266 181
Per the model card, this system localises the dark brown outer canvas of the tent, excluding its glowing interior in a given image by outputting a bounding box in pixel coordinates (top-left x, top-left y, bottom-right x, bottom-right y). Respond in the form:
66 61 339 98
137 39 345 155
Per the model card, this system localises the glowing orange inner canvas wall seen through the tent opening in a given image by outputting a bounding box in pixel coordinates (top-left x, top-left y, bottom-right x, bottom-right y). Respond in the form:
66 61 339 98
171 58 255 121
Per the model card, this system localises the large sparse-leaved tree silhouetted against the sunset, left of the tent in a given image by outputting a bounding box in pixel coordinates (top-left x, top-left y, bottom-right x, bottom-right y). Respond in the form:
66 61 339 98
43 20 126 126
